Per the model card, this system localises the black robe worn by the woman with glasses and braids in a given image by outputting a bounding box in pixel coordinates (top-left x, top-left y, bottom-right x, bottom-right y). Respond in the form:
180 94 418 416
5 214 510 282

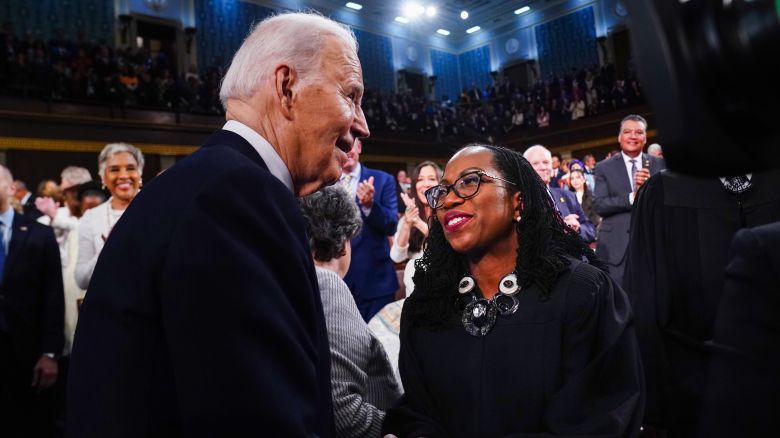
384 260 644 438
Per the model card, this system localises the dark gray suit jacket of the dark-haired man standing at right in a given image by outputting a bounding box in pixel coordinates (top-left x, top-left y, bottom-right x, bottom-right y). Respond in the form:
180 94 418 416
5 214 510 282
593 153 666 265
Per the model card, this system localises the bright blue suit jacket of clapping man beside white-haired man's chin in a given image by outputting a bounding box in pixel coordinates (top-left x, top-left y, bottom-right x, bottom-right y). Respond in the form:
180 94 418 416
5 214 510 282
344 165 398 299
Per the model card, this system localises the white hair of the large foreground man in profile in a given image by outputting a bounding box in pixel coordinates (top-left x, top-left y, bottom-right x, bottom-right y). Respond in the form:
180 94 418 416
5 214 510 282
219 12 357 107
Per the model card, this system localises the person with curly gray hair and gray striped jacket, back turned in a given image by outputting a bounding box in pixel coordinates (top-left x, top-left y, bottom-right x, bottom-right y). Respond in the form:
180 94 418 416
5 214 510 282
300 186 401 437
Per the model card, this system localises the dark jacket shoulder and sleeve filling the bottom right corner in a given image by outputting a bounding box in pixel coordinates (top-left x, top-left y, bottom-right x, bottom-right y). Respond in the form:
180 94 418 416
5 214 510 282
699 222 780 438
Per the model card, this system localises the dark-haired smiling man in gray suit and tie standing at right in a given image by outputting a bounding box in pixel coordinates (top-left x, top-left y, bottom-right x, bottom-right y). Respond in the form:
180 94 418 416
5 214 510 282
593 115 666 285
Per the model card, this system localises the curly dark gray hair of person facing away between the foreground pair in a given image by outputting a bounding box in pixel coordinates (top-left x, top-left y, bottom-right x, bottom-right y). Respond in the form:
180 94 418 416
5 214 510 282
298 186 362 262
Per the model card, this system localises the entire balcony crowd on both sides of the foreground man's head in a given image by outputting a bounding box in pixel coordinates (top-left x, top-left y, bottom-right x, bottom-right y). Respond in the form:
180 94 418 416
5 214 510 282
0 26 644 137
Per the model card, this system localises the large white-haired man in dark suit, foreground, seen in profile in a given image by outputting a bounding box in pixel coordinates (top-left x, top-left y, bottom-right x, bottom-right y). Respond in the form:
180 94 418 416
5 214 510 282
68 13 369 437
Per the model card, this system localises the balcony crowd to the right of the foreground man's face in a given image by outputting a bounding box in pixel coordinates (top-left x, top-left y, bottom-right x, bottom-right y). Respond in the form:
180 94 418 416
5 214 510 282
363 64 645 141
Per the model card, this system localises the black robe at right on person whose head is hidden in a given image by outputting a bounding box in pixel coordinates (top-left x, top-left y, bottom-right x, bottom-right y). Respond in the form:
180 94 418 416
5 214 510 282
624 171 780 437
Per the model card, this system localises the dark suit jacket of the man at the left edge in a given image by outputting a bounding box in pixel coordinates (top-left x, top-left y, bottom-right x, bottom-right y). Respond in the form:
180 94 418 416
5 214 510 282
0 213 65 366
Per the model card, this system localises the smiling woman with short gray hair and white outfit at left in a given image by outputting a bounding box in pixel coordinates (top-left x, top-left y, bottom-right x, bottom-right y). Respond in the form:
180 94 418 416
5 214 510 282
75 143 144 289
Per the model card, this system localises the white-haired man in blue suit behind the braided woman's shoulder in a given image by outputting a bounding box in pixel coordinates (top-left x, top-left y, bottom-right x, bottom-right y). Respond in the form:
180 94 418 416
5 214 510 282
523 144 596 242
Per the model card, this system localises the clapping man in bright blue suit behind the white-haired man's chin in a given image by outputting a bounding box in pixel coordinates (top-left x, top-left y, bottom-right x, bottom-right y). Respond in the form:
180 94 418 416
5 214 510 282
341 140 398 322
